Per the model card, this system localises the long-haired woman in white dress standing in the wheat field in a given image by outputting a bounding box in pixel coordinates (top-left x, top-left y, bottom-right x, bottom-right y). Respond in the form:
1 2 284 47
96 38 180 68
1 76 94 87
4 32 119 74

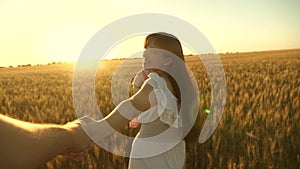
80 33 199 169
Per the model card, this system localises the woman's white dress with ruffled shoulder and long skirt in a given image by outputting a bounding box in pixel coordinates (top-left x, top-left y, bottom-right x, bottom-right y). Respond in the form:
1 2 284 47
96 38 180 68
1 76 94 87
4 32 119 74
128 73 185 169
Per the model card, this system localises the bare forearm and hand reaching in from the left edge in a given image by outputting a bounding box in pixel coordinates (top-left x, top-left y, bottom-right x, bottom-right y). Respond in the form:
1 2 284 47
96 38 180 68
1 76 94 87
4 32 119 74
0 114 90 169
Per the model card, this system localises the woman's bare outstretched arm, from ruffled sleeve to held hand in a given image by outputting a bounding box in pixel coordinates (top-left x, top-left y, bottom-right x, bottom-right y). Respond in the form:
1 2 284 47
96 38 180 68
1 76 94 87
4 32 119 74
79 83 153 145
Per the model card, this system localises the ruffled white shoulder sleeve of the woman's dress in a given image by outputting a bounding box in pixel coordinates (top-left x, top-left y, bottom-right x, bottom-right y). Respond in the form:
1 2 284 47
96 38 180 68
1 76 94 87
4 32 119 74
138 73 182 128
